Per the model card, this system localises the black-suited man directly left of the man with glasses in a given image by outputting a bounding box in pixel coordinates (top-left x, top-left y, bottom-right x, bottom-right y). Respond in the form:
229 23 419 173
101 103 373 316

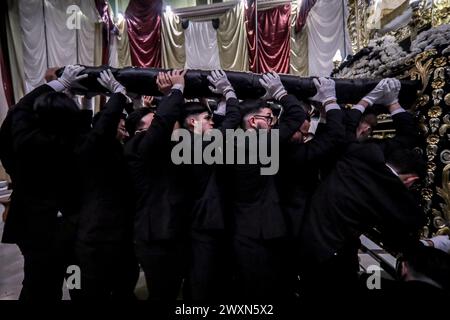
180 70 241 301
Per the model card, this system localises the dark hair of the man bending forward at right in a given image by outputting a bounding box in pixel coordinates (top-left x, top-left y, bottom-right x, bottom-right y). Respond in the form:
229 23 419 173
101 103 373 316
386 149 427 179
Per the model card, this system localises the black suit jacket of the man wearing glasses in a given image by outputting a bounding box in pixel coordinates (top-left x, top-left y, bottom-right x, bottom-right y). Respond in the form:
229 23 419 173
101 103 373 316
227 95 305 239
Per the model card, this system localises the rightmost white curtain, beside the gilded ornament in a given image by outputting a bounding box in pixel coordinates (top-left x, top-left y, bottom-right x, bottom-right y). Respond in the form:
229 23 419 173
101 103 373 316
306 0 351 76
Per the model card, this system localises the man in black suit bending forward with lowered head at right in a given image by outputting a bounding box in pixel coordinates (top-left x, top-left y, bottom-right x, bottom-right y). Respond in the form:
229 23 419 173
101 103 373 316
300 142 426 293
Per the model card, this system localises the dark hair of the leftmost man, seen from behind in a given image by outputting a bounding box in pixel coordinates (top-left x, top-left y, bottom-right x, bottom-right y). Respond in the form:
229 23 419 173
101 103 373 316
33 92 80 134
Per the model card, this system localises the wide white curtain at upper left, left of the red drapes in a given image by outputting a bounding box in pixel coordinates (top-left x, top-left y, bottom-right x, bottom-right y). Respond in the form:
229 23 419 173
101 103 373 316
16 0 101 92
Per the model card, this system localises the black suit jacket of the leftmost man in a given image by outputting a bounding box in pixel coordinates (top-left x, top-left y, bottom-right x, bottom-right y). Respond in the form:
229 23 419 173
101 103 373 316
2 85 79 245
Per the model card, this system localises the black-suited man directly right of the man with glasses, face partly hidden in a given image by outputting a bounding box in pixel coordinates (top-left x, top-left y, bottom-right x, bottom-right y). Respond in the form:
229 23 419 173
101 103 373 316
277 78 345 296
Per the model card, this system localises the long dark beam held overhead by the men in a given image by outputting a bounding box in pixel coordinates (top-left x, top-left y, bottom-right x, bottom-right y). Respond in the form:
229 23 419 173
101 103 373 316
57 66 420 108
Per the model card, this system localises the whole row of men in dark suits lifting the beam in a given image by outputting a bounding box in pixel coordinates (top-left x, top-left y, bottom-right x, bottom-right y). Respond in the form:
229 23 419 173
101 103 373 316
0 66 444 301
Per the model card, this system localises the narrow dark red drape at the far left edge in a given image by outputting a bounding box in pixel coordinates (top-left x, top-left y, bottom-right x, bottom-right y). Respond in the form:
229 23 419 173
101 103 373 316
0 1 14 107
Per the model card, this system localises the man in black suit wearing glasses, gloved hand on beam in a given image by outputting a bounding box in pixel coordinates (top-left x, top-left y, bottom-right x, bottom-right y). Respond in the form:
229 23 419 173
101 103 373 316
226 73 306 300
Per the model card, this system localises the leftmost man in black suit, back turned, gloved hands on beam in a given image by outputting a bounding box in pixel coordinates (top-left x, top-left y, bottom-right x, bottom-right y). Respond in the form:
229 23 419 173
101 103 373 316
2 66 85 300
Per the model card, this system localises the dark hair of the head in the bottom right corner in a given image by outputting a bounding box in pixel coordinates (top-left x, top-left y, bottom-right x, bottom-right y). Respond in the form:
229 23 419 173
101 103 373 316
400 244 450 290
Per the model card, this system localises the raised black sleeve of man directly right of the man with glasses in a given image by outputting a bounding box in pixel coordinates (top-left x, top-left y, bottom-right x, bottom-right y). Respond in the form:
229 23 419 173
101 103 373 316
287 109 345 164
